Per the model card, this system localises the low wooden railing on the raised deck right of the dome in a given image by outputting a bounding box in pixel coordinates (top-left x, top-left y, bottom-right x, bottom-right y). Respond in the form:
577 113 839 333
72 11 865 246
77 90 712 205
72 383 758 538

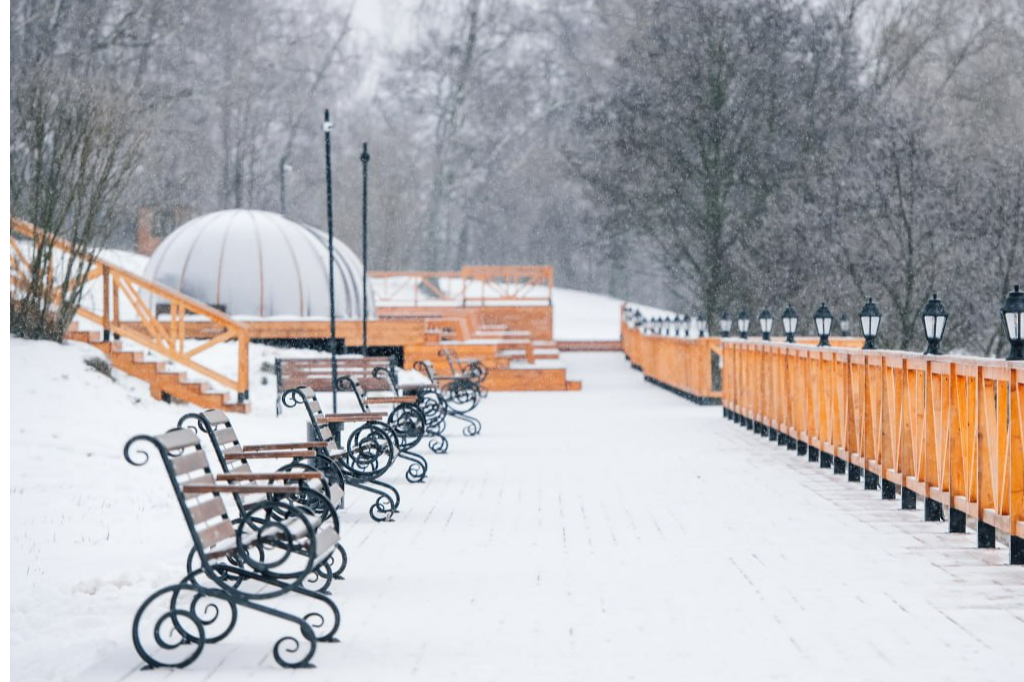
370 265 555 307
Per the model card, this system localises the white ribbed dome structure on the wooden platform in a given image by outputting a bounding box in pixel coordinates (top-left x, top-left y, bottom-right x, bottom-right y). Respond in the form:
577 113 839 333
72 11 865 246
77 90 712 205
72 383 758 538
145 209 376 319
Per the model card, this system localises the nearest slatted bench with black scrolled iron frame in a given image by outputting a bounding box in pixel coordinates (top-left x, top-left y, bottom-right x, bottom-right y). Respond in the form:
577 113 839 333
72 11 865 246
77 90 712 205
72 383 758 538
124 428 341 668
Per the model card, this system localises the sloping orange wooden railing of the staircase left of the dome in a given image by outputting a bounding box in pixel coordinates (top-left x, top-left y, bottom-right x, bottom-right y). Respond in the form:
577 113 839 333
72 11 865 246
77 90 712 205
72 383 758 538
10 217 249 399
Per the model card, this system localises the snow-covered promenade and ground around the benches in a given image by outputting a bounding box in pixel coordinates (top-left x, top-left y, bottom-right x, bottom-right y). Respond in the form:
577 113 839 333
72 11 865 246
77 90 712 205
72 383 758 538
11 342 1024 682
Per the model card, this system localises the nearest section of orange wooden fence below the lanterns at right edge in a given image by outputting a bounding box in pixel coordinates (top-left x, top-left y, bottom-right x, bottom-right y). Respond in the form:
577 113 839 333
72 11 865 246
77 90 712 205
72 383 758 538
722 340 1024 562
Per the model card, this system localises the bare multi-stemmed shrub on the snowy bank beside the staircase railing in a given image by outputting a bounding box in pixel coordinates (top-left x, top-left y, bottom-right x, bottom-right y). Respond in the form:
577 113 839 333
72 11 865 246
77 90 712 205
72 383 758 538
10 70 142 340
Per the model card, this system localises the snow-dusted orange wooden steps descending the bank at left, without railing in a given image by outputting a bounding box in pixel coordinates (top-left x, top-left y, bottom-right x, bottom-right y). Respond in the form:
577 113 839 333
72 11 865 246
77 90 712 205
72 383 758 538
65 324 250 413
